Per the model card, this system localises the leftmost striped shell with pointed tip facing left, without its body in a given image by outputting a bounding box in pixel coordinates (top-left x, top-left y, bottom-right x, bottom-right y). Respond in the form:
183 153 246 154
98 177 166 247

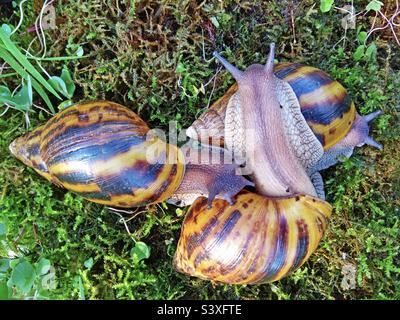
10 101 185 207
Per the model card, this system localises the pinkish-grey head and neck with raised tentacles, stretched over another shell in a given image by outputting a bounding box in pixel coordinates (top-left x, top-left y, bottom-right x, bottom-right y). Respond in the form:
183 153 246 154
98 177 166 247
214 44 322 196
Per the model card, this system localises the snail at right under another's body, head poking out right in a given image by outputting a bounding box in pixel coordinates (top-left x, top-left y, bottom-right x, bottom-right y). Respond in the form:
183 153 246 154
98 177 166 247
187 51 382 199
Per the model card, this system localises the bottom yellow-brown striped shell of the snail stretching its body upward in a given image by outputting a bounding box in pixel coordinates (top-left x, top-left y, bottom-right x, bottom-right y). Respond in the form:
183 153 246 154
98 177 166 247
174 191 332 284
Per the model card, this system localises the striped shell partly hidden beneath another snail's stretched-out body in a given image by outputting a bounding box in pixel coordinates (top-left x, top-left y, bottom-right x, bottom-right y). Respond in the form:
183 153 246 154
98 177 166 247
187 63 356 150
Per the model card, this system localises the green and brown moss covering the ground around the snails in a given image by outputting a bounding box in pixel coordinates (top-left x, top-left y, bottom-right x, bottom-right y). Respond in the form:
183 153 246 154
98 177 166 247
0 1 400 299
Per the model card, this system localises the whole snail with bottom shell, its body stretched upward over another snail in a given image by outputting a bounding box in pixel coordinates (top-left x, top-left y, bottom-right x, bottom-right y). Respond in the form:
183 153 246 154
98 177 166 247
174 44 332 284
